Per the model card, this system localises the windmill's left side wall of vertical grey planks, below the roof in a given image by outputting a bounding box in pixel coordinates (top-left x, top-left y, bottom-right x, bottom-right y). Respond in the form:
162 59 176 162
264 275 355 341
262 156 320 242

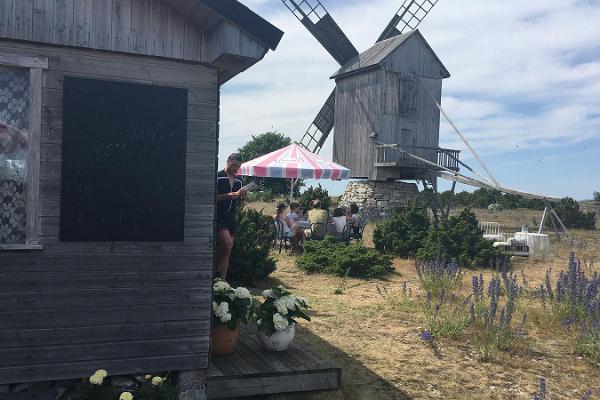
333 70 383 178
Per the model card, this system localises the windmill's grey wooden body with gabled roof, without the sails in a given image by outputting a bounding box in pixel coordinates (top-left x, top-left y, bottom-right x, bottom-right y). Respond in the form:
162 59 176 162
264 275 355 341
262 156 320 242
332 30 458 181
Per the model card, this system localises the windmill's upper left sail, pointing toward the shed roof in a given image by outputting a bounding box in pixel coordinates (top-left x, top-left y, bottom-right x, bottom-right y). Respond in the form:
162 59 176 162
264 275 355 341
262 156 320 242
281 0 358 65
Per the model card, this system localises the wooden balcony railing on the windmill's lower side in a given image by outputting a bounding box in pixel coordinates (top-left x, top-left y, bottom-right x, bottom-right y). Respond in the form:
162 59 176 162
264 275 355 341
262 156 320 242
376 145 460 171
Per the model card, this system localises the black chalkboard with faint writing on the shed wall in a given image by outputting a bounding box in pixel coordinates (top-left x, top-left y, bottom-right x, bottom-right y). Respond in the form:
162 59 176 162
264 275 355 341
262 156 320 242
60 77 187 241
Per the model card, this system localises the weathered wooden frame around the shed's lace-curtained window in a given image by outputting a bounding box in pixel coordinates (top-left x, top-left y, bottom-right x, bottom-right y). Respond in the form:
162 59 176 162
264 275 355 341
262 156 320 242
0 53 48 251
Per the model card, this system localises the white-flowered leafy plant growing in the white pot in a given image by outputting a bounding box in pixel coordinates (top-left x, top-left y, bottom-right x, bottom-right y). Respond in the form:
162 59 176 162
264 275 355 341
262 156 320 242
255 286 310 336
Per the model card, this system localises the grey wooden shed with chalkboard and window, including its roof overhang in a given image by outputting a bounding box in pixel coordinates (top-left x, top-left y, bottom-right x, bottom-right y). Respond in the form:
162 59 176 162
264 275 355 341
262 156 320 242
0 0 282 384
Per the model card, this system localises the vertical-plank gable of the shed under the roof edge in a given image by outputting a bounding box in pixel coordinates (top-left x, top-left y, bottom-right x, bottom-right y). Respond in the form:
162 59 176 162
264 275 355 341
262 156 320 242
0 0 267 77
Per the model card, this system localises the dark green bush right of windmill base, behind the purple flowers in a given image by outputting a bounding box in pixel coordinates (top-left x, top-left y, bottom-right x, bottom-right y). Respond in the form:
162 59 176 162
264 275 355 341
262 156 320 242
416 209 506 268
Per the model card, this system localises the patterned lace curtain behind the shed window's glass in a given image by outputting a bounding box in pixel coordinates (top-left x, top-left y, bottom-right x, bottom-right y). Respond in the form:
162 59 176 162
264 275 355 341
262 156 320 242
0 66 29 244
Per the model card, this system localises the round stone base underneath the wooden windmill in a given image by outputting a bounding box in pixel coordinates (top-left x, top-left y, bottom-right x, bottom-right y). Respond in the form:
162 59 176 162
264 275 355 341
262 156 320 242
340 181 419 213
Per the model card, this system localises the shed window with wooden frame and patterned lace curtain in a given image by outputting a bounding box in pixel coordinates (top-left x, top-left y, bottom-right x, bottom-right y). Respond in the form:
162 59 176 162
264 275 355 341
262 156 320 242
0 53 48 250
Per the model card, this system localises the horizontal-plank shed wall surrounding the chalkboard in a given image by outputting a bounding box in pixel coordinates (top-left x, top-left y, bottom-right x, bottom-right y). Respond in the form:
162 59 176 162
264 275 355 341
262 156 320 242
0 40 218 383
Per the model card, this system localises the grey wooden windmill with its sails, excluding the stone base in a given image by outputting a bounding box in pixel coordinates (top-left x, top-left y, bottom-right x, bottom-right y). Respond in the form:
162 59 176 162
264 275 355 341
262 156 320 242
282 0 459 212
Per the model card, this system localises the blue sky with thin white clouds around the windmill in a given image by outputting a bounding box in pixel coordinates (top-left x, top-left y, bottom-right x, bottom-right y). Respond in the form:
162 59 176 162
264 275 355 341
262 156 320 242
220 0 600 199
